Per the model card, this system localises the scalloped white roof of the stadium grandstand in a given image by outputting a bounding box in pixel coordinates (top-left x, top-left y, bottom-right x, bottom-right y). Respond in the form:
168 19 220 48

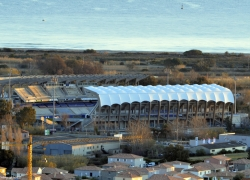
86 84 234 106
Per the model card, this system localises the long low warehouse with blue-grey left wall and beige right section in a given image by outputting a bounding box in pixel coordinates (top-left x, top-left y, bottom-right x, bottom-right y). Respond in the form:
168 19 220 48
44 140 120 156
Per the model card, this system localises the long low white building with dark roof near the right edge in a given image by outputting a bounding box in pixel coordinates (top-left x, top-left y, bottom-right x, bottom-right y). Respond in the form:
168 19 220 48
189 141 247 154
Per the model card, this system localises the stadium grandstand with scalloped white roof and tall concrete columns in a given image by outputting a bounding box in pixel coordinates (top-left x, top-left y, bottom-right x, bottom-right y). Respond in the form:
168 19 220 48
85 84 234 130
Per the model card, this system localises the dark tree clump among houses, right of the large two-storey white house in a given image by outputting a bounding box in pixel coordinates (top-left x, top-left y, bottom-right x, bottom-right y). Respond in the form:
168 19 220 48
165 144 189 162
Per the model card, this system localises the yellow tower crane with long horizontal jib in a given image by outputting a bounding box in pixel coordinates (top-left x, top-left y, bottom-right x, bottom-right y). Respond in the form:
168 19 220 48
2 135 142 180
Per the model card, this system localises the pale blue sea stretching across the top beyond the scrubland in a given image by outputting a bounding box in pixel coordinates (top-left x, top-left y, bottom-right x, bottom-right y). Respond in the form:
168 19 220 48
0 0 250 53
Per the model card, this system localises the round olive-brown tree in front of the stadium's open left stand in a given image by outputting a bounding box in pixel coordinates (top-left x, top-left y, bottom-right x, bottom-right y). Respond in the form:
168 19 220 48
16 107 36 127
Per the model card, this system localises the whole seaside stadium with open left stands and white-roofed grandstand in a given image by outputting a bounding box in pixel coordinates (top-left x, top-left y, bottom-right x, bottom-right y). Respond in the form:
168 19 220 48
0 75 234 132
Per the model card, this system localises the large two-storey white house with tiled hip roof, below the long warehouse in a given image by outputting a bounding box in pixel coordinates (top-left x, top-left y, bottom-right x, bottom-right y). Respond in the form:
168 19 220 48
108 153 146 167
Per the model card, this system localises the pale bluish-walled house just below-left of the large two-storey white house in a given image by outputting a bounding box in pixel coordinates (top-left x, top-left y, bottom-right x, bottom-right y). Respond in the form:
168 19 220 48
74 166 102 178
